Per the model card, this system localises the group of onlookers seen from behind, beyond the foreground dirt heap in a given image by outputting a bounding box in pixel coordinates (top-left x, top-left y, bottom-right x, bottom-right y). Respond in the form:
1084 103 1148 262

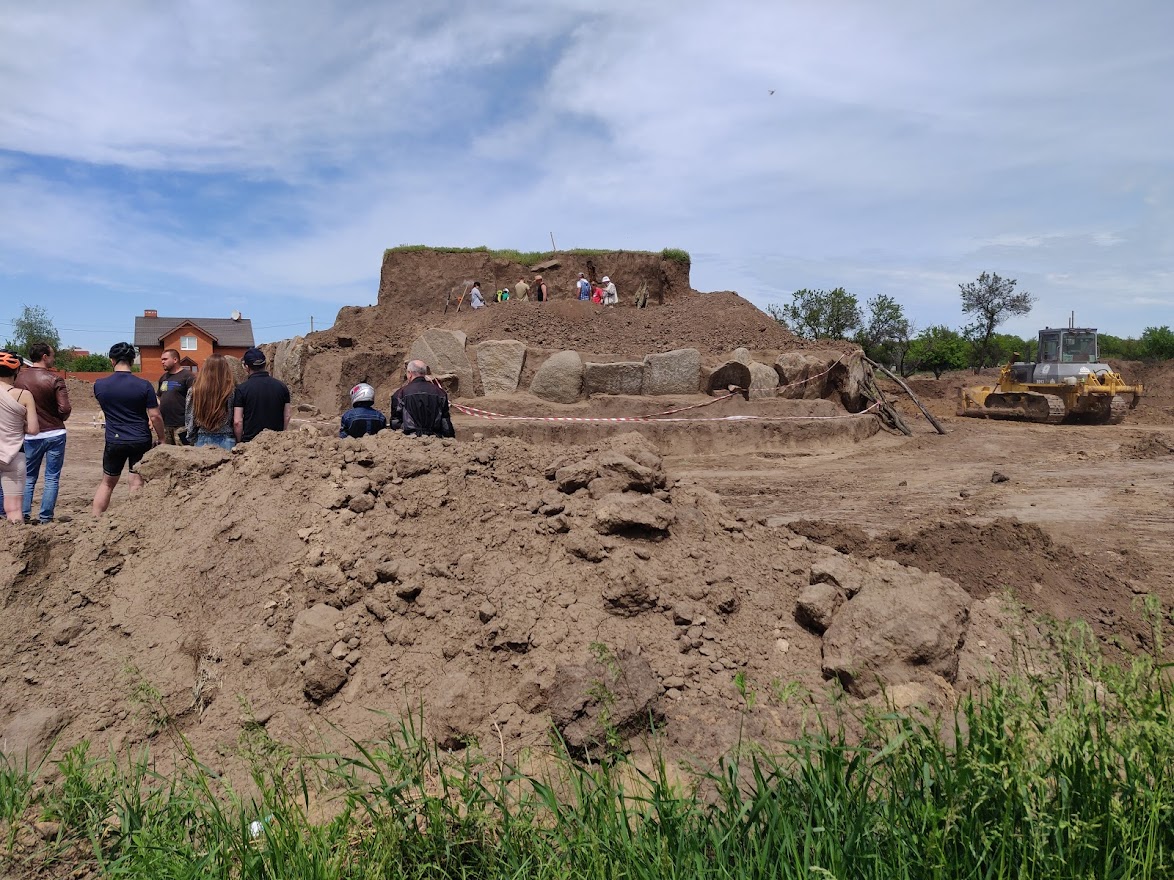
0 343 456 524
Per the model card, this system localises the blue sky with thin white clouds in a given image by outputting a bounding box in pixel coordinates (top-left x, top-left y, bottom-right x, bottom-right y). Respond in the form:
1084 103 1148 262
0 0 1174 350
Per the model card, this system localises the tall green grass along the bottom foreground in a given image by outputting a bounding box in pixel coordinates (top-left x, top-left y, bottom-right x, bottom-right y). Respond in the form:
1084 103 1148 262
0 614 1174 880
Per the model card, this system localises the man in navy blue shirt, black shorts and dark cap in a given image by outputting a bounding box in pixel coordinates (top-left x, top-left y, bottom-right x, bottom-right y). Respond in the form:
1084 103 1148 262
94 343 166 516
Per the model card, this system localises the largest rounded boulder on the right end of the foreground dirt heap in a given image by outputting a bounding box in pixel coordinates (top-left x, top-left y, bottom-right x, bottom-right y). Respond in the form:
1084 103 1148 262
823 561 970 697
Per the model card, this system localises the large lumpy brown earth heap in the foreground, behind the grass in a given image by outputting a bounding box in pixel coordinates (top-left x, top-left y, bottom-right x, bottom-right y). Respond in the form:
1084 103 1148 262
0 431 1042 763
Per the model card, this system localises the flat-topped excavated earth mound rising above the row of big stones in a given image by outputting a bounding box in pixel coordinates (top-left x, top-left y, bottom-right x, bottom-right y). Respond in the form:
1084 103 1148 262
280 250 852 409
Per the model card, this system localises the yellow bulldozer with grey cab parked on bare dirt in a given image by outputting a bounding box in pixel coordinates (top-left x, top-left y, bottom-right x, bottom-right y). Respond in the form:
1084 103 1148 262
958 327 1142 425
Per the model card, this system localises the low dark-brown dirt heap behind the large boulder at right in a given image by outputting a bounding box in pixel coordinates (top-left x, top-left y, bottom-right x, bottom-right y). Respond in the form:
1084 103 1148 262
790 519 1151 650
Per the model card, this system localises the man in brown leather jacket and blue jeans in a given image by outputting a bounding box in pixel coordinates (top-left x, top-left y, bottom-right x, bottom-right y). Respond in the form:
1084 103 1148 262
15 343 73 524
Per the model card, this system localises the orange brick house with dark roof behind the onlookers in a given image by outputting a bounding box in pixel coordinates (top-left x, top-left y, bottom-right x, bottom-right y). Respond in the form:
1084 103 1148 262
135 309 254 383
